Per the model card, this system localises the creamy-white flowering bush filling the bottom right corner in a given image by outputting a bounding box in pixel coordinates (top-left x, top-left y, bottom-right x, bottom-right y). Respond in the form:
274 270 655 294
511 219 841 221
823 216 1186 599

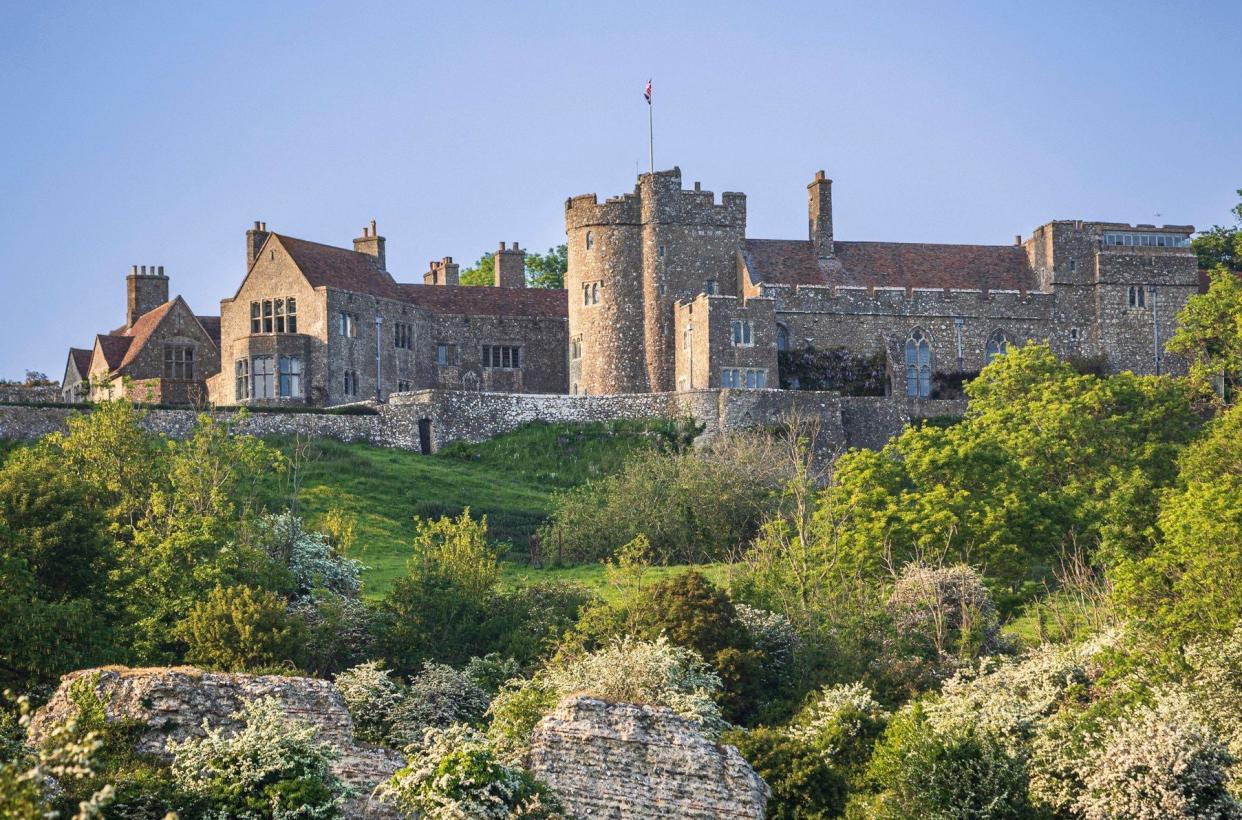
1076 691 1242 820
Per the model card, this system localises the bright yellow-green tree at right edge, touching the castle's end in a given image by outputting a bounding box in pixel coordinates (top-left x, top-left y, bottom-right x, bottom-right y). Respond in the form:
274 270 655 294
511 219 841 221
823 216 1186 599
1166 265 1242 403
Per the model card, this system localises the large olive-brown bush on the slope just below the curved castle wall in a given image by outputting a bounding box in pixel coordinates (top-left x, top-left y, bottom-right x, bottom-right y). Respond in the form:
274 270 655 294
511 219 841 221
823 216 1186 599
539 436 784 564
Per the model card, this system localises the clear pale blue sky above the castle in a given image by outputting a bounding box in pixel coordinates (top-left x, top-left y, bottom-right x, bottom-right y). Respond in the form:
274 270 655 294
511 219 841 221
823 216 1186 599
0 0 1242 379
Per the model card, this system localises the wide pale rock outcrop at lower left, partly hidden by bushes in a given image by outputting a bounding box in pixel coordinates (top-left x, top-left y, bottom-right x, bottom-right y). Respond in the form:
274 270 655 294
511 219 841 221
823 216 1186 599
30 666 402 818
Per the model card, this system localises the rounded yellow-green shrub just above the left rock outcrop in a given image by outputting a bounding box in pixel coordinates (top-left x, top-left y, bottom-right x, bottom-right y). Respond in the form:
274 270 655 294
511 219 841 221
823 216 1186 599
181 586 298 672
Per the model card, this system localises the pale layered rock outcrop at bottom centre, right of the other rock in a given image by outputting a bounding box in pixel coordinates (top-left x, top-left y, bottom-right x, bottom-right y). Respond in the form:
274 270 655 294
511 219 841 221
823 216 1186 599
529 696 769 820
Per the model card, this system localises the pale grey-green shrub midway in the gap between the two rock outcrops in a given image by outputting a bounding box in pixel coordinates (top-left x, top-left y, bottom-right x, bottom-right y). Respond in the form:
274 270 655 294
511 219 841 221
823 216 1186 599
388 663 491 747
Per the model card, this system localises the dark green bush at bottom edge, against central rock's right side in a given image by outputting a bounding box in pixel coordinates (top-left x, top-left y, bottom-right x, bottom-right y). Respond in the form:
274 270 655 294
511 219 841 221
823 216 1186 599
722 727 846 820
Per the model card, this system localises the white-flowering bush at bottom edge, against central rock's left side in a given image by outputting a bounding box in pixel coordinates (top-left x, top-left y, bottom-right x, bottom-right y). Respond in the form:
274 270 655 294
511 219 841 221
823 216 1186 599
379 724 564 820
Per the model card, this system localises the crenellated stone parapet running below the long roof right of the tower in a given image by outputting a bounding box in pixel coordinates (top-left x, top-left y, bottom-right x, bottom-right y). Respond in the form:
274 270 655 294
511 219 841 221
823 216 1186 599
764 285 1053 319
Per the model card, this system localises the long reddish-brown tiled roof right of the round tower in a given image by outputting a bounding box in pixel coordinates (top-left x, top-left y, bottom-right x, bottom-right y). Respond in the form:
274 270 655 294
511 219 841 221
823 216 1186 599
744 240 1036 291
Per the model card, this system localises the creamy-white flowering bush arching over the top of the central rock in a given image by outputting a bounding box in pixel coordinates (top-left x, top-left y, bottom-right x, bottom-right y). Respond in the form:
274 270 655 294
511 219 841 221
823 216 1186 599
488 636 728 754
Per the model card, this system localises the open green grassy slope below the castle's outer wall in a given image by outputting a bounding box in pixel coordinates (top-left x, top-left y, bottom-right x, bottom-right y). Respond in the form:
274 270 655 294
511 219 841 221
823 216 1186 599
265 420 691 595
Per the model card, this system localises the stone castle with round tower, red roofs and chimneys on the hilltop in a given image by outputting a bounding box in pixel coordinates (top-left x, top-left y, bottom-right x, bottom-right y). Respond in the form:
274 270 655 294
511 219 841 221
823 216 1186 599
63 168 1200 405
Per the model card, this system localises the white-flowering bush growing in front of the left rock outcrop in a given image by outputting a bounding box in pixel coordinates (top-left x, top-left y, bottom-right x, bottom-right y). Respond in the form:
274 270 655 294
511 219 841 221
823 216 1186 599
168 697 349 820
